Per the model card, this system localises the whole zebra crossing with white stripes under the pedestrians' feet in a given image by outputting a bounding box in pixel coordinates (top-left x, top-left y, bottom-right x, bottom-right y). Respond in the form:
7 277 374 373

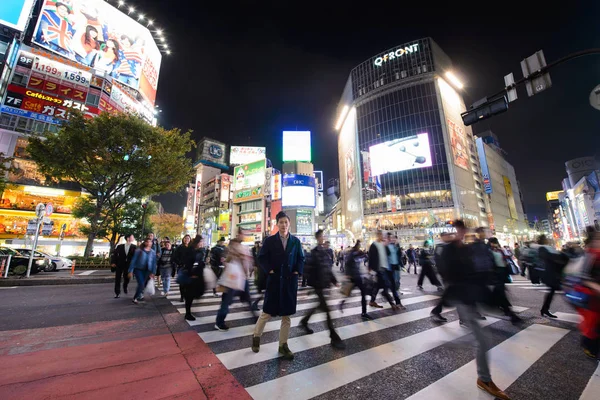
161 276 600 400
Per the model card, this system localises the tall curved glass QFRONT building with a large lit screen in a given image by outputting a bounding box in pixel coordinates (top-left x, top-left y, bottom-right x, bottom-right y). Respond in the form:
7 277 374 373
336 38 500 244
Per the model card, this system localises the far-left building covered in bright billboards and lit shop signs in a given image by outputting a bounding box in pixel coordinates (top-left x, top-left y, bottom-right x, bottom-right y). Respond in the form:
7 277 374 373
0 0 164 255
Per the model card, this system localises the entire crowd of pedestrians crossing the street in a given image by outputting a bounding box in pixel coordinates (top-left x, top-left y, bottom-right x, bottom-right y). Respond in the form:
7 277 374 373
112 219 600 399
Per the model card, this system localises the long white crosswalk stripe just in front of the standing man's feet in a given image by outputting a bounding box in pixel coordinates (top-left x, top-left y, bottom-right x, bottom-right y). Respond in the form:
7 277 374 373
246 318 498 400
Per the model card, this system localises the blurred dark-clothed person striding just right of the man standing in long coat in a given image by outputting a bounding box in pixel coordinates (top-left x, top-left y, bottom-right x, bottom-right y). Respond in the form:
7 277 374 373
300 229 346 349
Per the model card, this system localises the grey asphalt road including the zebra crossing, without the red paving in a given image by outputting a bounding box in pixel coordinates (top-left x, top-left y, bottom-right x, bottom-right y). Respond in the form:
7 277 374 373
0 274 600 400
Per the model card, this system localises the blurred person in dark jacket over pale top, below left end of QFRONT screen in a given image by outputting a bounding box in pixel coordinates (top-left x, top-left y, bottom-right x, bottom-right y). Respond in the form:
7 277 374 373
369 230 405 311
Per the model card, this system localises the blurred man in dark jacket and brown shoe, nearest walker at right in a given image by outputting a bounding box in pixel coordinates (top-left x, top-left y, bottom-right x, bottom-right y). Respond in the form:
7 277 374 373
442 220 509 400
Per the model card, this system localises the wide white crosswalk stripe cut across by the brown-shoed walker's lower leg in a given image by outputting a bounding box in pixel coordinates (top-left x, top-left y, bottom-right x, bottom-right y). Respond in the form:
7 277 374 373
409 325 569 400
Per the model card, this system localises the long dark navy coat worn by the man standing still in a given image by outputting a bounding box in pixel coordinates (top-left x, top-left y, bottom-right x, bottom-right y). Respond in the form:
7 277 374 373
258 233 304 316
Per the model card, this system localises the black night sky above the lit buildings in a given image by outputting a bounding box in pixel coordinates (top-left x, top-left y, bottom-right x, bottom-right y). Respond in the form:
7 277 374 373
146 0 600 219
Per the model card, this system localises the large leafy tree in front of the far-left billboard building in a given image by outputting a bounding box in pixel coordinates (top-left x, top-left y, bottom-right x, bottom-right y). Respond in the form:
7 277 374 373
27 113 194 256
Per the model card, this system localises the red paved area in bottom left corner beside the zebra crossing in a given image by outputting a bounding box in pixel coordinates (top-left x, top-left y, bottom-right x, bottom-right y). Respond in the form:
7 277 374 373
0 300 250 400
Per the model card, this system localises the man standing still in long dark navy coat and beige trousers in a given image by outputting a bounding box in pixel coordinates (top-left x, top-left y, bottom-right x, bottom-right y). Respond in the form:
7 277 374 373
252 211 304 360
